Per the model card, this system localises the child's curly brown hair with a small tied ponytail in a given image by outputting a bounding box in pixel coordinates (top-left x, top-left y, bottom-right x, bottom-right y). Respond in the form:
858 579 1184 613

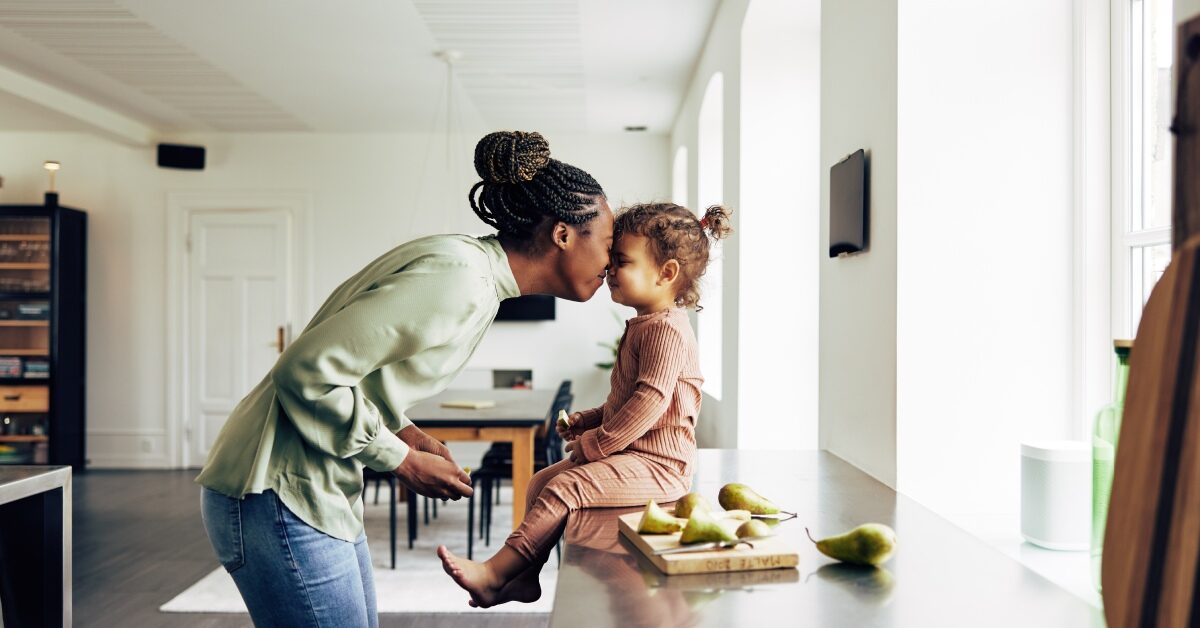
613 203 733 312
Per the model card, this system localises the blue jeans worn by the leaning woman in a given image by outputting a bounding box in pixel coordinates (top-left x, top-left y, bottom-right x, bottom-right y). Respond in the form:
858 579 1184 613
200 489 379 628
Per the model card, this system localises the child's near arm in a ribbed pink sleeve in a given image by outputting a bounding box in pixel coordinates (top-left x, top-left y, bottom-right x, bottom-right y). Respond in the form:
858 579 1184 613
576 323 685 462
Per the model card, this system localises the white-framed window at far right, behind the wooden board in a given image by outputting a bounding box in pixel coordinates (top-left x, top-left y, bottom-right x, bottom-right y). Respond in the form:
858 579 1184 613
1114 0 1175 337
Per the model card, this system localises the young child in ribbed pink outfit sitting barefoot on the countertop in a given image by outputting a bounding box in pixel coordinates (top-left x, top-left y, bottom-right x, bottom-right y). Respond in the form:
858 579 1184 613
438 203 732 608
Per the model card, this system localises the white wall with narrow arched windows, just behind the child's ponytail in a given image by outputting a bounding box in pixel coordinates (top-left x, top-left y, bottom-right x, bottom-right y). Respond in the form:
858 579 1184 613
671 0 749 448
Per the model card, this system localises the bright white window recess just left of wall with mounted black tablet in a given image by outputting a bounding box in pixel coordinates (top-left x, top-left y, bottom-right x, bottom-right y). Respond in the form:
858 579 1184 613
737 0 821 449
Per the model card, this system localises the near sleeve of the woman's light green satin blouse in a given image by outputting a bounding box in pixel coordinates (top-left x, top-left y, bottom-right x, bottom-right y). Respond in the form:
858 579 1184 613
271 269 481 471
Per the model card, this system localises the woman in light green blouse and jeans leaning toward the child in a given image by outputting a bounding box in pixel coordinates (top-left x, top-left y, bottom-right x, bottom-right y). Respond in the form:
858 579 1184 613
197 132 613 627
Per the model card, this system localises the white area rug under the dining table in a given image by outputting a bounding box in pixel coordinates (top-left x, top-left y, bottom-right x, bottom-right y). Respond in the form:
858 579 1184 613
158 486 558 614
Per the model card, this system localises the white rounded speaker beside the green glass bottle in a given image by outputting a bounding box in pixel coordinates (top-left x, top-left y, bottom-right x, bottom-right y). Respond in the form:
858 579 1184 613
1021 441 1092 550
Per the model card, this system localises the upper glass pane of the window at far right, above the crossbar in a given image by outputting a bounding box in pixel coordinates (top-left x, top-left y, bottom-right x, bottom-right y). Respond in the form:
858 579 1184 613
1130 0 1175 231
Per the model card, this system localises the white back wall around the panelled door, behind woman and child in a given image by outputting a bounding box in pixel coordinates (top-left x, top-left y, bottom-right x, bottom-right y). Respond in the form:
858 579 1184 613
0 133 671 467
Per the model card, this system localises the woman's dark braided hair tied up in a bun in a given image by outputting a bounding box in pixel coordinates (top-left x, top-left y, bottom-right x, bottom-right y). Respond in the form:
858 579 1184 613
468 131 604 244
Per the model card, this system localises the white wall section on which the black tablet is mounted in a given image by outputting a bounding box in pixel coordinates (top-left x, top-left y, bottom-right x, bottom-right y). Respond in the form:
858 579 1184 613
818 0 902 486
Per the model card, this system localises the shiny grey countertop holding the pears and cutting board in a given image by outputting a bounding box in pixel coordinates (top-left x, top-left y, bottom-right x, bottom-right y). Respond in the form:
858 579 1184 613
550 449 1104 628
